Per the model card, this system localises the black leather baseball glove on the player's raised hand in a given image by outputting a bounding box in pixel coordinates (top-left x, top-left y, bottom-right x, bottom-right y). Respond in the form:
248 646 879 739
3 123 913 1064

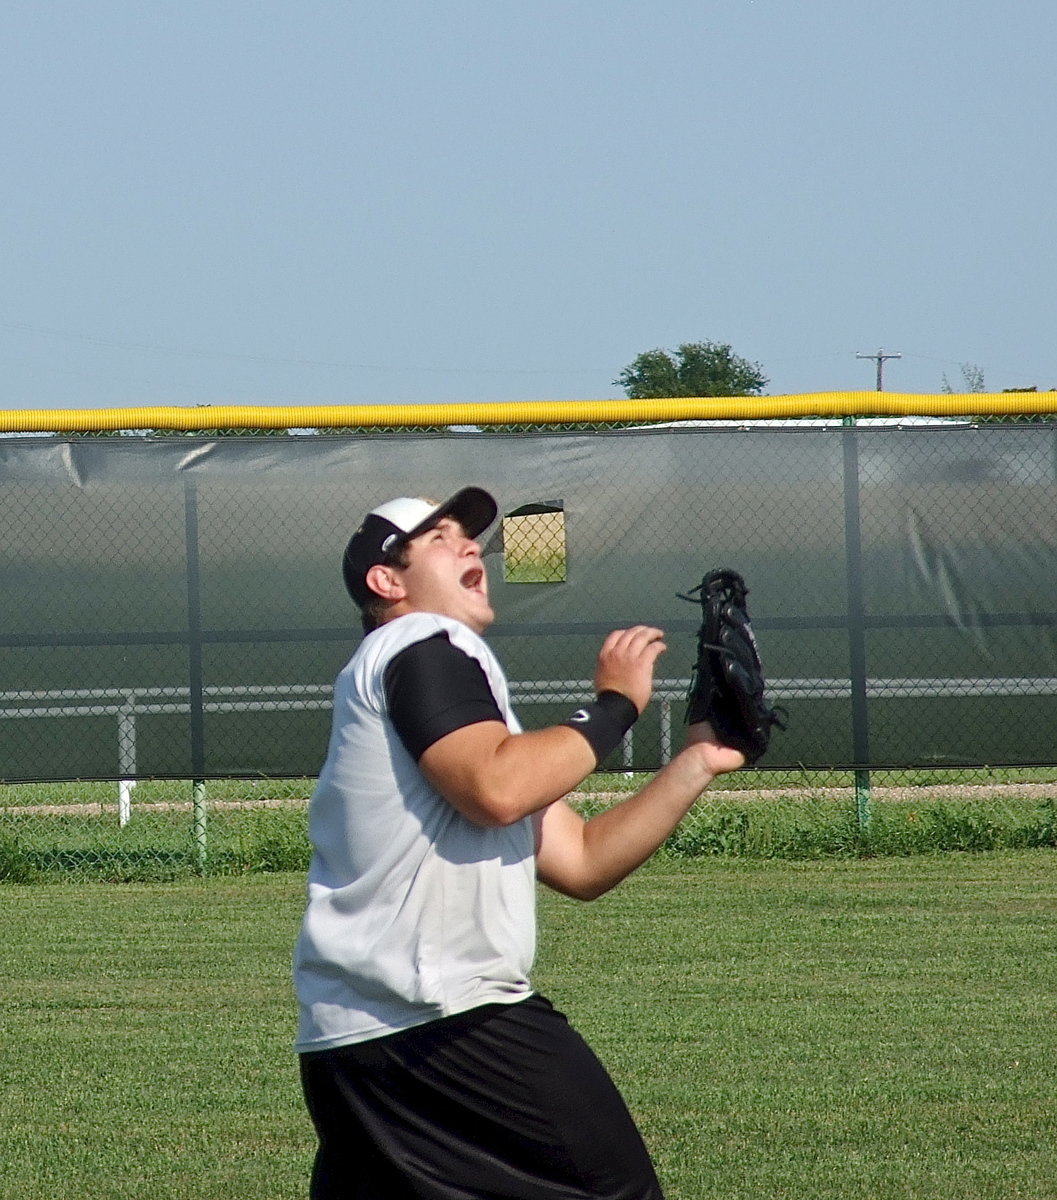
679 570 786 763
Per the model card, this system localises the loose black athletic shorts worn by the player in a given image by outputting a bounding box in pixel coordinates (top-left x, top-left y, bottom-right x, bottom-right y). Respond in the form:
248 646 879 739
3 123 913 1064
301 996 662 1200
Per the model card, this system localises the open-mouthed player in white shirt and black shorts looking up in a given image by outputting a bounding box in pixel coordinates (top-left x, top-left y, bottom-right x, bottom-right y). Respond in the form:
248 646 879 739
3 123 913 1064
295 487 744 1200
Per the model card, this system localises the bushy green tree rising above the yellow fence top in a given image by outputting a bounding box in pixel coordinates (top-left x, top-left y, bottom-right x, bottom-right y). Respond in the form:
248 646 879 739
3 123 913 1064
613 342 767 400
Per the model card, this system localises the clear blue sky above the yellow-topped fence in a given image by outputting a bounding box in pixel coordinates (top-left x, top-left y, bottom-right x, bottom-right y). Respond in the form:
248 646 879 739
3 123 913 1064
0 0 1057 408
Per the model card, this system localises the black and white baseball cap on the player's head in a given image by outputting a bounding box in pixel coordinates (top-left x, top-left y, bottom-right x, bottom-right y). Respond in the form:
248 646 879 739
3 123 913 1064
342 487 499 608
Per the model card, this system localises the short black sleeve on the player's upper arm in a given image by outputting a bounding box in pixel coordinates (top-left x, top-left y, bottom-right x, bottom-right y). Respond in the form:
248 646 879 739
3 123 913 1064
383 634 503 762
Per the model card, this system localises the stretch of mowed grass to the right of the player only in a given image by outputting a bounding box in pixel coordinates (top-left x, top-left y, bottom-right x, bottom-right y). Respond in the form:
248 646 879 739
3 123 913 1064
537 852 1057 1200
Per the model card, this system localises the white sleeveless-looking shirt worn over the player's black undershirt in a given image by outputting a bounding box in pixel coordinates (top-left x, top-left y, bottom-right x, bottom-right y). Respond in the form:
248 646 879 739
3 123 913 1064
294 613 536 1051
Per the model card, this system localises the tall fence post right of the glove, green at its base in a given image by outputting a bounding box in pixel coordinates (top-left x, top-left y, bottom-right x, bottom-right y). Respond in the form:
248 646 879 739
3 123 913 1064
841 416 872 833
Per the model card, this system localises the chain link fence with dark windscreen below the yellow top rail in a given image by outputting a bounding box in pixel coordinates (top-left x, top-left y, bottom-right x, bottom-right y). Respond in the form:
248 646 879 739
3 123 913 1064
0 420 1057 878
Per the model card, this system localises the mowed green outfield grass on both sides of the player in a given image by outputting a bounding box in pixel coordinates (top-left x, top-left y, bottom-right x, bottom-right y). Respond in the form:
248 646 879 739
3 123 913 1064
0 850 1057 1200
